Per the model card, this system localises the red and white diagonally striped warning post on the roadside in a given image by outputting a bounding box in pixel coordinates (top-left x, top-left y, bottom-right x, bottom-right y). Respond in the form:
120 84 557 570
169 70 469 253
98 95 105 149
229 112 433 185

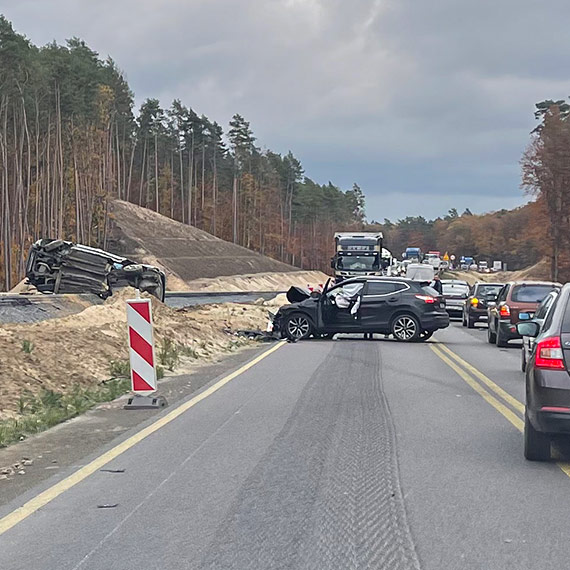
127 299 156 393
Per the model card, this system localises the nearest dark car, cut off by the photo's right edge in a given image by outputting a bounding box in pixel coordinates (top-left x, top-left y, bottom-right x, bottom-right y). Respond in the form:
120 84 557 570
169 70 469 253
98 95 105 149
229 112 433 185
517 284 570 461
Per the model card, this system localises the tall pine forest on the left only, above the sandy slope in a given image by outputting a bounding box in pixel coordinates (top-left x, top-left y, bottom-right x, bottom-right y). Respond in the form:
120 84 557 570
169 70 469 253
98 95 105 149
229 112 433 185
0 17 364 289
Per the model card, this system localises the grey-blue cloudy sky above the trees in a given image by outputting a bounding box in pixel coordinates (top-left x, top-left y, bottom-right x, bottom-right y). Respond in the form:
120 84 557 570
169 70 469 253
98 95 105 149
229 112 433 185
0 0 570 220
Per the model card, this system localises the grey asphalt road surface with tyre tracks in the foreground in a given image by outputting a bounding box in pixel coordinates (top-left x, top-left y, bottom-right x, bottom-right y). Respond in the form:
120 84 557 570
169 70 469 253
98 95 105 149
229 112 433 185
0 324 570 570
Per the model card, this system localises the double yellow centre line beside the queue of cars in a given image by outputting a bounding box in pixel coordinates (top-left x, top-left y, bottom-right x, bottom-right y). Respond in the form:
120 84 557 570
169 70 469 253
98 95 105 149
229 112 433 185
429 343 570 477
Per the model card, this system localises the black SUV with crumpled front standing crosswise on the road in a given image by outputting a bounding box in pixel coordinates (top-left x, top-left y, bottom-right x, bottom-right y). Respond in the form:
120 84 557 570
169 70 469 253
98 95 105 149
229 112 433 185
273 277 449 342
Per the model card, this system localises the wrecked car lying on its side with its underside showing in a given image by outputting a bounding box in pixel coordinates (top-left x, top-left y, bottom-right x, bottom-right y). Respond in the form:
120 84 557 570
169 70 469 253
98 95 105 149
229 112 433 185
26 239 166 301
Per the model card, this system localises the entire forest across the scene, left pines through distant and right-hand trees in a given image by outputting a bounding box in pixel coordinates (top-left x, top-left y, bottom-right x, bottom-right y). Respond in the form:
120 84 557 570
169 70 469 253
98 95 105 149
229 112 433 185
0 16 560 289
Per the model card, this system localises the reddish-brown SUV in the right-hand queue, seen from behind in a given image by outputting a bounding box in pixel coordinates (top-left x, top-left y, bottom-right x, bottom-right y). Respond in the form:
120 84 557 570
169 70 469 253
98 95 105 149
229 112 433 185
487 281 560 347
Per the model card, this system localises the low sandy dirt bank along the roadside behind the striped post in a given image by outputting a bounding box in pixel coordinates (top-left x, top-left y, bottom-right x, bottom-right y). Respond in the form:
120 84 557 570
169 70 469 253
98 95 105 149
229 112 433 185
0 289 282 419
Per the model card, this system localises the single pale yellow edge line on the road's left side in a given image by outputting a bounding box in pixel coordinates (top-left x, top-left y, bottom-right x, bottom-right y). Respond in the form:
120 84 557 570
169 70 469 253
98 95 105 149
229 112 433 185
0 342 285 535
